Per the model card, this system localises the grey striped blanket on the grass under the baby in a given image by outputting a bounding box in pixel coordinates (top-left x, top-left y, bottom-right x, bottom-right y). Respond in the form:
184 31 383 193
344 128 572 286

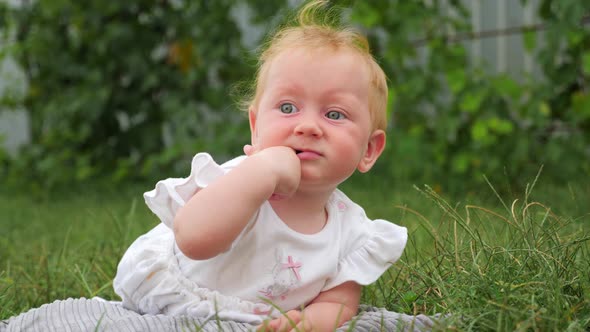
0 298 438 332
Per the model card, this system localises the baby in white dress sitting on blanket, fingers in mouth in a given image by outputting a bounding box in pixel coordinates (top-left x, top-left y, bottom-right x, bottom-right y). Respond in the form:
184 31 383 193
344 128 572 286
114 1 407 331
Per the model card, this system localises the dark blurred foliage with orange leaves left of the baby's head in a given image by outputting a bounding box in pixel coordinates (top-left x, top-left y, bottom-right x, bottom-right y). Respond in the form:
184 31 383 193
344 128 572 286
1 0 262 187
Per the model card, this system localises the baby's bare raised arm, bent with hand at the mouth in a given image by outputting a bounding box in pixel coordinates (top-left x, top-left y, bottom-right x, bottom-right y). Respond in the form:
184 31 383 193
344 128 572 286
174 146 301 259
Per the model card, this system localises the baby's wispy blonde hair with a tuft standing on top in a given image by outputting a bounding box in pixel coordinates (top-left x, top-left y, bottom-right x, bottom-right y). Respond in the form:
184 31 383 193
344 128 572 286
244 0 388 130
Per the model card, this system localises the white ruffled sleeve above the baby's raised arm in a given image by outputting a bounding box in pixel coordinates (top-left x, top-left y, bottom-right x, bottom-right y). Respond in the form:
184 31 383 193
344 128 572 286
143 153 245 228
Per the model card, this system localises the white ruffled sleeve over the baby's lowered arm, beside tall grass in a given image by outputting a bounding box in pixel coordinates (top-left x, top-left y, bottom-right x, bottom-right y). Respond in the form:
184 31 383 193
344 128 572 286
323 196 408 291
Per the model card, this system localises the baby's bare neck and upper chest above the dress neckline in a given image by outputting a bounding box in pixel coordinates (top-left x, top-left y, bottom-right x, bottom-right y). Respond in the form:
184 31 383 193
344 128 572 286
270 192 332 234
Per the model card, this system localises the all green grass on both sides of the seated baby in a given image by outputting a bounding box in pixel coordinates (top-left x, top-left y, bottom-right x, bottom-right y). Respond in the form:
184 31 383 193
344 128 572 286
0 180 590 331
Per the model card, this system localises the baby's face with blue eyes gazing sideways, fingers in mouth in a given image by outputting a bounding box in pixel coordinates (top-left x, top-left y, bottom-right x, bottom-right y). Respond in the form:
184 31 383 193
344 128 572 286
250 48 384 189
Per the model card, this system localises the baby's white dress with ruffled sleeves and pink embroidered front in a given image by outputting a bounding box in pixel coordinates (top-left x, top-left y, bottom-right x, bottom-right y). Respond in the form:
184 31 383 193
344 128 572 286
113 153 407 324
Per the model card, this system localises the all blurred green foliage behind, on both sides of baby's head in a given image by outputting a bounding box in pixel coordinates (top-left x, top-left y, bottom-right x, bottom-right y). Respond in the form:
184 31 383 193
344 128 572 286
2 0 590 191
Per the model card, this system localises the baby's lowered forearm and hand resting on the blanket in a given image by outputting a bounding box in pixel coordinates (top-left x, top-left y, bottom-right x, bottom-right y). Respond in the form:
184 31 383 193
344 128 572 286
258 281 361 332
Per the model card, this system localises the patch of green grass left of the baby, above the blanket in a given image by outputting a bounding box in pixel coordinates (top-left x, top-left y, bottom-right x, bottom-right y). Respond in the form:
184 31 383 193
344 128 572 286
0 184 157 319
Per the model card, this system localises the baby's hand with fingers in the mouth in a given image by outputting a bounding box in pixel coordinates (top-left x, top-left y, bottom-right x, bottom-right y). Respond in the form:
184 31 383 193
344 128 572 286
244 145 301 199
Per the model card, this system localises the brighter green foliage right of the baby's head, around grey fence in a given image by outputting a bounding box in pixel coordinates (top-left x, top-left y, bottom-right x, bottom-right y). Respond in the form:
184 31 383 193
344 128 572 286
352 1 590 191
